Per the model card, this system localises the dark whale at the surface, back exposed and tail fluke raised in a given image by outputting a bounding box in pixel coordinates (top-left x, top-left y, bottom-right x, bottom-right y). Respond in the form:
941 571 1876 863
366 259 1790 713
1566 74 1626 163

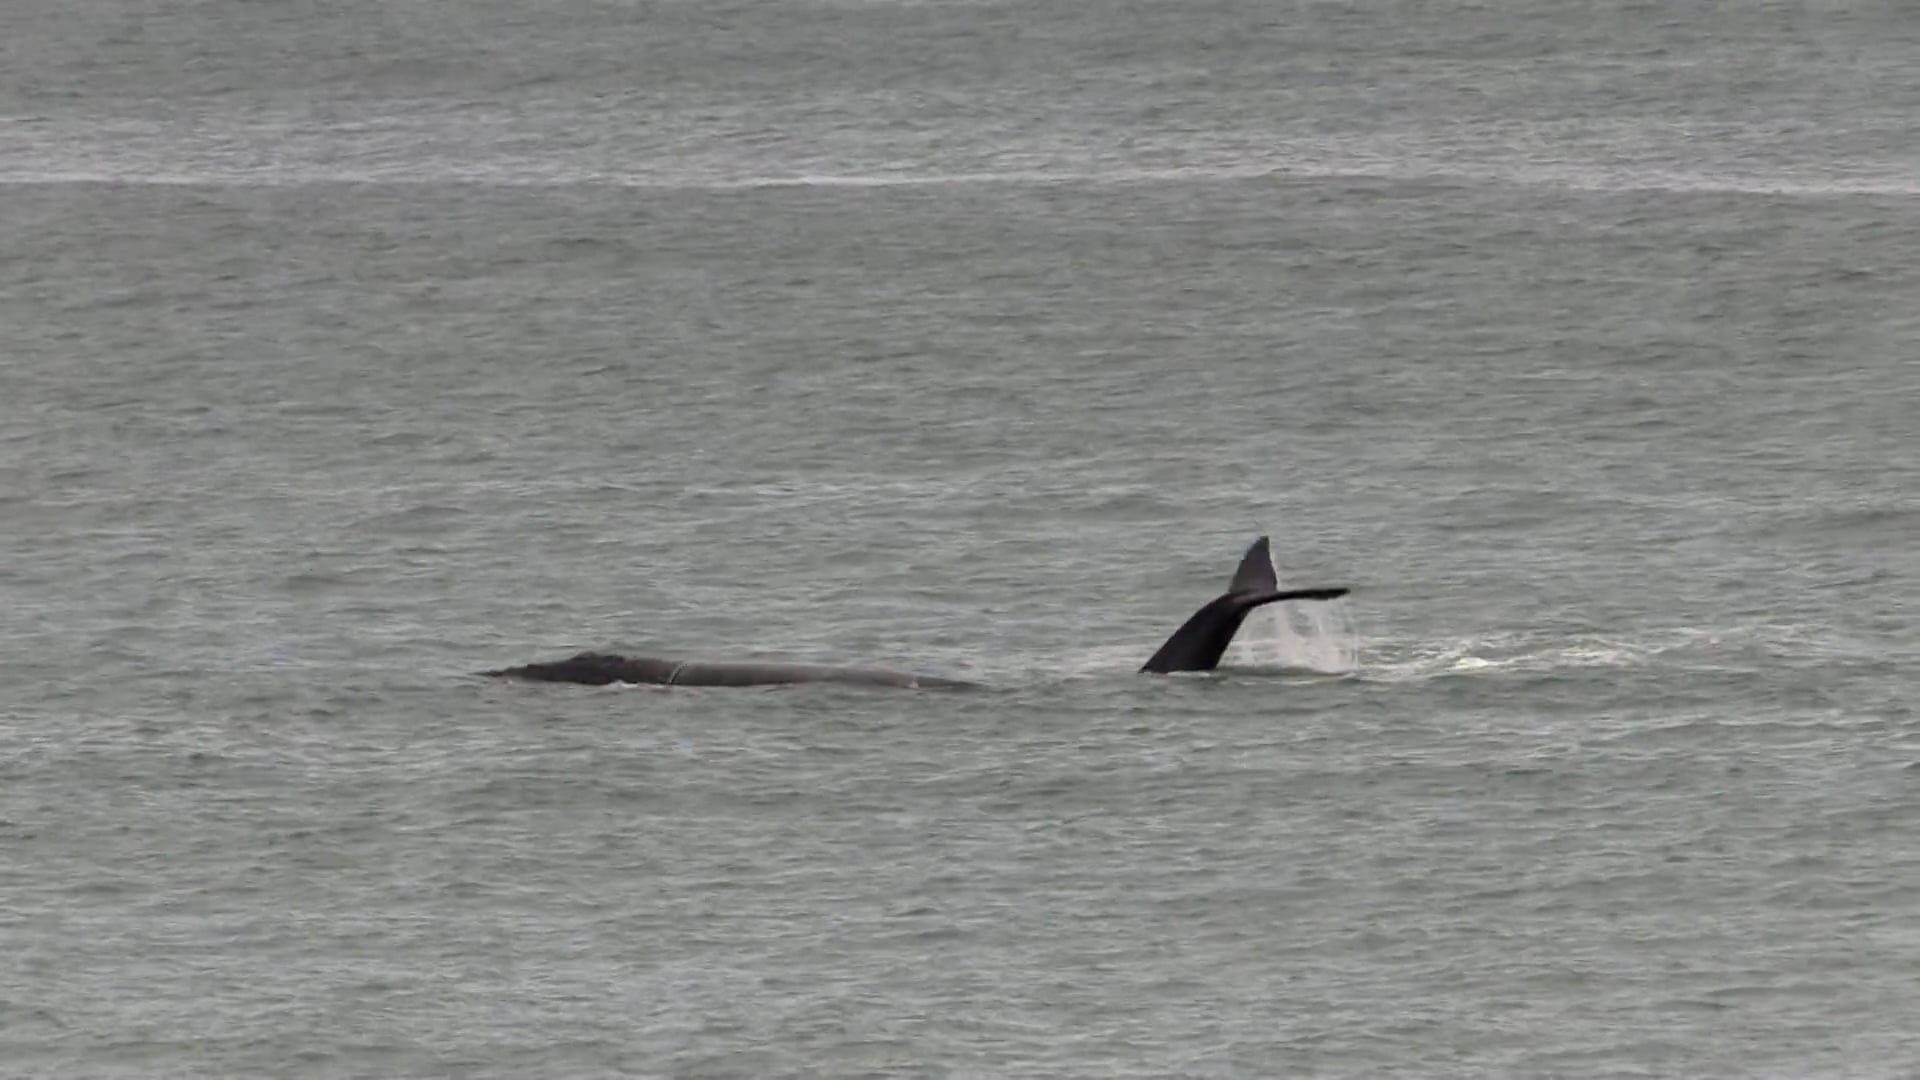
478 536 1352 690
